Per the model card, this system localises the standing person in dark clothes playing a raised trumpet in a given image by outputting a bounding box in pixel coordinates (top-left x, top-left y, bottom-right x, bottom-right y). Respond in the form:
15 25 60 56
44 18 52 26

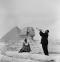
36 27 49 55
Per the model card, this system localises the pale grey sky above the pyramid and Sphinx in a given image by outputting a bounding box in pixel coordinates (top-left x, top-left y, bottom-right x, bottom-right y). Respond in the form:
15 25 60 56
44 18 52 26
0 0 60 39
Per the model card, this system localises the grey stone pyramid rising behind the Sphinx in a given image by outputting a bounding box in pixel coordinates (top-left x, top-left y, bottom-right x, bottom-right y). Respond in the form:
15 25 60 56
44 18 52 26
0 26 21 43
